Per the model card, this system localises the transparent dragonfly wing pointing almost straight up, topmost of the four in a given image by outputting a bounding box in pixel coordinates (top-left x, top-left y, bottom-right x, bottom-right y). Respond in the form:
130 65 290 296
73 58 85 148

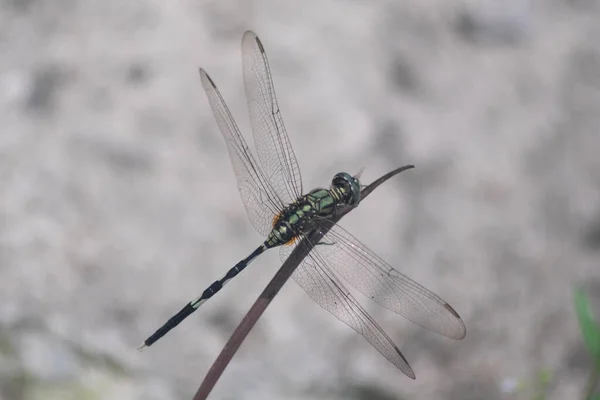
242 31 302 204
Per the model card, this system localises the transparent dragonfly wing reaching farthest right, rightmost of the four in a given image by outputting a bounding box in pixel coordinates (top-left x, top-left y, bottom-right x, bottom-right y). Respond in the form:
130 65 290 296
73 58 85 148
312 219 467 339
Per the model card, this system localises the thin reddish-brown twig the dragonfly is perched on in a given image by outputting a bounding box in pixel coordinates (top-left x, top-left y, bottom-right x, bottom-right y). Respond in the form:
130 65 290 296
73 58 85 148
194 165 414 400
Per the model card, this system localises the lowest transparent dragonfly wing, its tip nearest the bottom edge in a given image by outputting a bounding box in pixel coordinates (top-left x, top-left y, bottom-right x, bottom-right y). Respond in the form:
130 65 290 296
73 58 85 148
280 245 415 379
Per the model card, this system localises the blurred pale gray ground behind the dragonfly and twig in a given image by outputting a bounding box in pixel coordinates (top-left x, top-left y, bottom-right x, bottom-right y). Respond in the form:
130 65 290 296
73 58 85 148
0 0 600 400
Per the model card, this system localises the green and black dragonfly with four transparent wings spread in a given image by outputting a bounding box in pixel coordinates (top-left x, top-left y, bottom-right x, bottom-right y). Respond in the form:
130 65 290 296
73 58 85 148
139 31 466 379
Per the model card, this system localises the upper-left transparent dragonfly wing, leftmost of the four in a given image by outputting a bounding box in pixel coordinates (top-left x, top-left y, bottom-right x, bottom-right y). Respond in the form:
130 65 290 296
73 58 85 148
200 69 284 236
